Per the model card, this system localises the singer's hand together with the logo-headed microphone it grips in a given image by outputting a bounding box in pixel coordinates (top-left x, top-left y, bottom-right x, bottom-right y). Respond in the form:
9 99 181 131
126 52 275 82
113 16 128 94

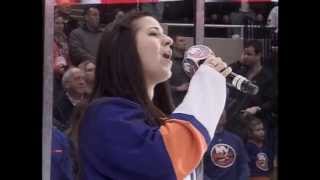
182 45 259 95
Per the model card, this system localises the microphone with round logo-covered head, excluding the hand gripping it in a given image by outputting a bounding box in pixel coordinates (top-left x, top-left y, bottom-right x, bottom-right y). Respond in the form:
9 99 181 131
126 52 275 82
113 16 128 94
182 45 259 95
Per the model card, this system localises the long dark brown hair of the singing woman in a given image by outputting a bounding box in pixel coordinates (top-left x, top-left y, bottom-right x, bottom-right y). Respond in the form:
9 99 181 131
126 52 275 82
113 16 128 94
92 11 173 125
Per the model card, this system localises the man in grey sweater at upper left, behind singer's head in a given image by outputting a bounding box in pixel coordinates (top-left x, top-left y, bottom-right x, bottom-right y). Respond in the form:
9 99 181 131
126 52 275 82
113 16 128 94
69 7 102 66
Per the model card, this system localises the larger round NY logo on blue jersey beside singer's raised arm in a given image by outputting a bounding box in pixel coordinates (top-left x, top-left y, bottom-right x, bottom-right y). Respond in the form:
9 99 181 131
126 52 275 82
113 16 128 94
210 144 237 168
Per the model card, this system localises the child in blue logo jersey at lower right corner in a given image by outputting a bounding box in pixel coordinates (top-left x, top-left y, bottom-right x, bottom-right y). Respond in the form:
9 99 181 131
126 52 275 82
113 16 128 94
244 115 273 180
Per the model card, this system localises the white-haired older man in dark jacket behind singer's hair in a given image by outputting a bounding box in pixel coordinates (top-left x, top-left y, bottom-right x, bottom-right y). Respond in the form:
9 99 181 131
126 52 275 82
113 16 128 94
53 67 88 131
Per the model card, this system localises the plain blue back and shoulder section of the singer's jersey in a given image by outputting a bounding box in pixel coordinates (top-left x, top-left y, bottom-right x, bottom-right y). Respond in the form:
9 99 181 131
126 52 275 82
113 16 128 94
79 98 176 180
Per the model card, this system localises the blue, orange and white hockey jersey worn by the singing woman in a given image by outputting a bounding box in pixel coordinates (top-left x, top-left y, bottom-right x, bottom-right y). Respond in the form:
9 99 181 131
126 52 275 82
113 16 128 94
79 65 226 180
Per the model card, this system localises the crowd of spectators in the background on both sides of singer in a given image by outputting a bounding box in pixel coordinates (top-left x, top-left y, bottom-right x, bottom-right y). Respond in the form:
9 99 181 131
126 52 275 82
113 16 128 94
52 2 278 180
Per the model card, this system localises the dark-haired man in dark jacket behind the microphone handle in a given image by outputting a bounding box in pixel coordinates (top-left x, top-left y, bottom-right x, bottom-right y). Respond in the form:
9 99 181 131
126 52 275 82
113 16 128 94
227 40 274 140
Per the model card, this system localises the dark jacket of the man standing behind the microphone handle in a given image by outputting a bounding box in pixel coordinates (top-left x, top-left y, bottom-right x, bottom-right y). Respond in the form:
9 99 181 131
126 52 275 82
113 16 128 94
226 62 275 137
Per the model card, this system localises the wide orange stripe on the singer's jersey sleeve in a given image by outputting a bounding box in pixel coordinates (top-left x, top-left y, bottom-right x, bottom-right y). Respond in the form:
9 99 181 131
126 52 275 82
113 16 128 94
160 119 207 180
